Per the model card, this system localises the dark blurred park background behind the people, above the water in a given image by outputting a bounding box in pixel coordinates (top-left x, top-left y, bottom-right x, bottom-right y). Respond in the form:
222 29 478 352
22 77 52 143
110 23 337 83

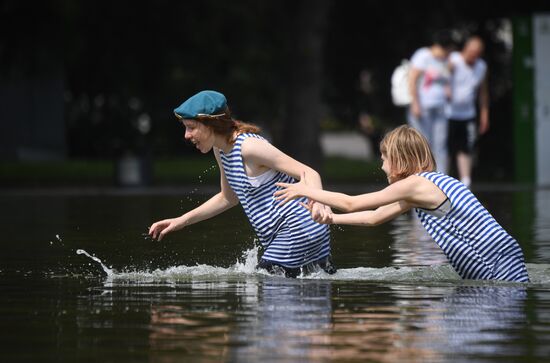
0 0 550 187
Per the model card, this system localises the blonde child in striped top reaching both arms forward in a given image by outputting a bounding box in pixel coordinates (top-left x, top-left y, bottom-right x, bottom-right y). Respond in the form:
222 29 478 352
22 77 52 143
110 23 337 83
275 126 529 282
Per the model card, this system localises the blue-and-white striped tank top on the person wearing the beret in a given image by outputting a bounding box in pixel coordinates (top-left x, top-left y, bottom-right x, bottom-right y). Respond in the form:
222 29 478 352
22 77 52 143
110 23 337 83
220 133 330 268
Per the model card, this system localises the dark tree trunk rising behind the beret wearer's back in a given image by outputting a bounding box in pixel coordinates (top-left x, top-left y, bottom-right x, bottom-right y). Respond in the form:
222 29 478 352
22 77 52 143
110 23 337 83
278 0 330 169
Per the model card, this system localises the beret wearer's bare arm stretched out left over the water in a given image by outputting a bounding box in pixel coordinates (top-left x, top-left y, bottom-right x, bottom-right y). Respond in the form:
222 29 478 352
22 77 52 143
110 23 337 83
149 150 239 241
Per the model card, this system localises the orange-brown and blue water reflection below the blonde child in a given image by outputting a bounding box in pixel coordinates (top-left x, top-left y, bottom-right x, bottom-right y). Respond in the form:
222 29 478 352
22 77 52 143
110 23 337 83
331 286 526 362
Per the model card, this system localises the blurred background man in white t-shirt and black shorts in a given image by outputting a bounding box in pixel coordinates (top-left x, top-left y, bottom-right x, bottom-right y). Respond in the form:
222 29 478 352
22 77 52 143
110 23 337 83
448 36 489 187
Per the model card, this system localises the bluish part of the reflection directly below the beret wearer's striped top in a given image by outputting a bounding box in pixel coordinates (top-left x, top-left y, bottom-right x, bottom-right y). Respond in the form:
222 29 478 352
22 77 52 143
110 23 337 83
231 278 332 361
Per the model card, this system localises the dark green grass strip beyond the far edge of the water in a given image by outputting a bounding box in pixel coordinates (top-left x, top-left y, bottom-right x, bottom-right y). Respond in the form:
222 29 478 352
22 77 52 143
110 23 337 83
0 156 385 187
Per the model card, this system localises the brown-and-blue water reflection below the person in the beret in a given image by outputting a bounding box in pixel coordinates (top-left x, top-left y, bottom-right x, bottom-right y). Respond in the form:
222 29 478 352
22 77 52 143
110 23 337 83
150 278 331 361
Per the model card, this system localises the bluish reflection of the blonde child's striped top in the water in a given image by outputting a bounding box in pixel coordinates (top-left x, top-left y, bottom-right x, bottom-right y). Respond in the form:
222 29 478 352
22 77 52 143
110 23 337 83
420 286 526 361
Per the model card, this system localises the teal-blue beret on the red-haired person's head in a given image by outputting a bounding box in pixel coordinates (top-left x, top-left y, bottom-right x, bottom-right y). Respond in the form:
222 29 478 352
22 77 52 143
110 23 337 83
174 91 227 119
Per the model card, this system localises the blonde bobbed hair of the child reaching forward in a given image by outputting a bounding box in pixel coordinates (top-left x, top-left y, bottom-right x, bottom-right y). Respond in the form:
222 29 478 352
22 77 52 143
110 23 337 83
380 125 436 183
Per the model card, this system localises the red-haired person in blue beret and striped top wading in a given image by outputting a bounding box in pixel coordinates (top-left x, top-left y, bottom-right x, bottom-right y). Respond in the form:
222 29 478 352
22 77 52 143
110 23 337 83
149 91 336 277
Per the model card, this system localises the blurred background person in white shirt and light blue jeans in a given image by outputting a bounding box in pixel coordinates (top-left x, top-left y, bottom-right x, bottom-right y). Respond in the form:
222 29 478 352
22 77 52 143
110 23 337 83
408 30 454 173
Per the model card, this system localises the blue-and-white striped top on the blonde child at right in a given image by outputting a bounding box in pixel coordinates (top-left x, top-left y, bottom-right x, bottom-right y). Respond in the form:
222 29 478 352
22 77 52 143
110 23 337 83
416 172 529 282
